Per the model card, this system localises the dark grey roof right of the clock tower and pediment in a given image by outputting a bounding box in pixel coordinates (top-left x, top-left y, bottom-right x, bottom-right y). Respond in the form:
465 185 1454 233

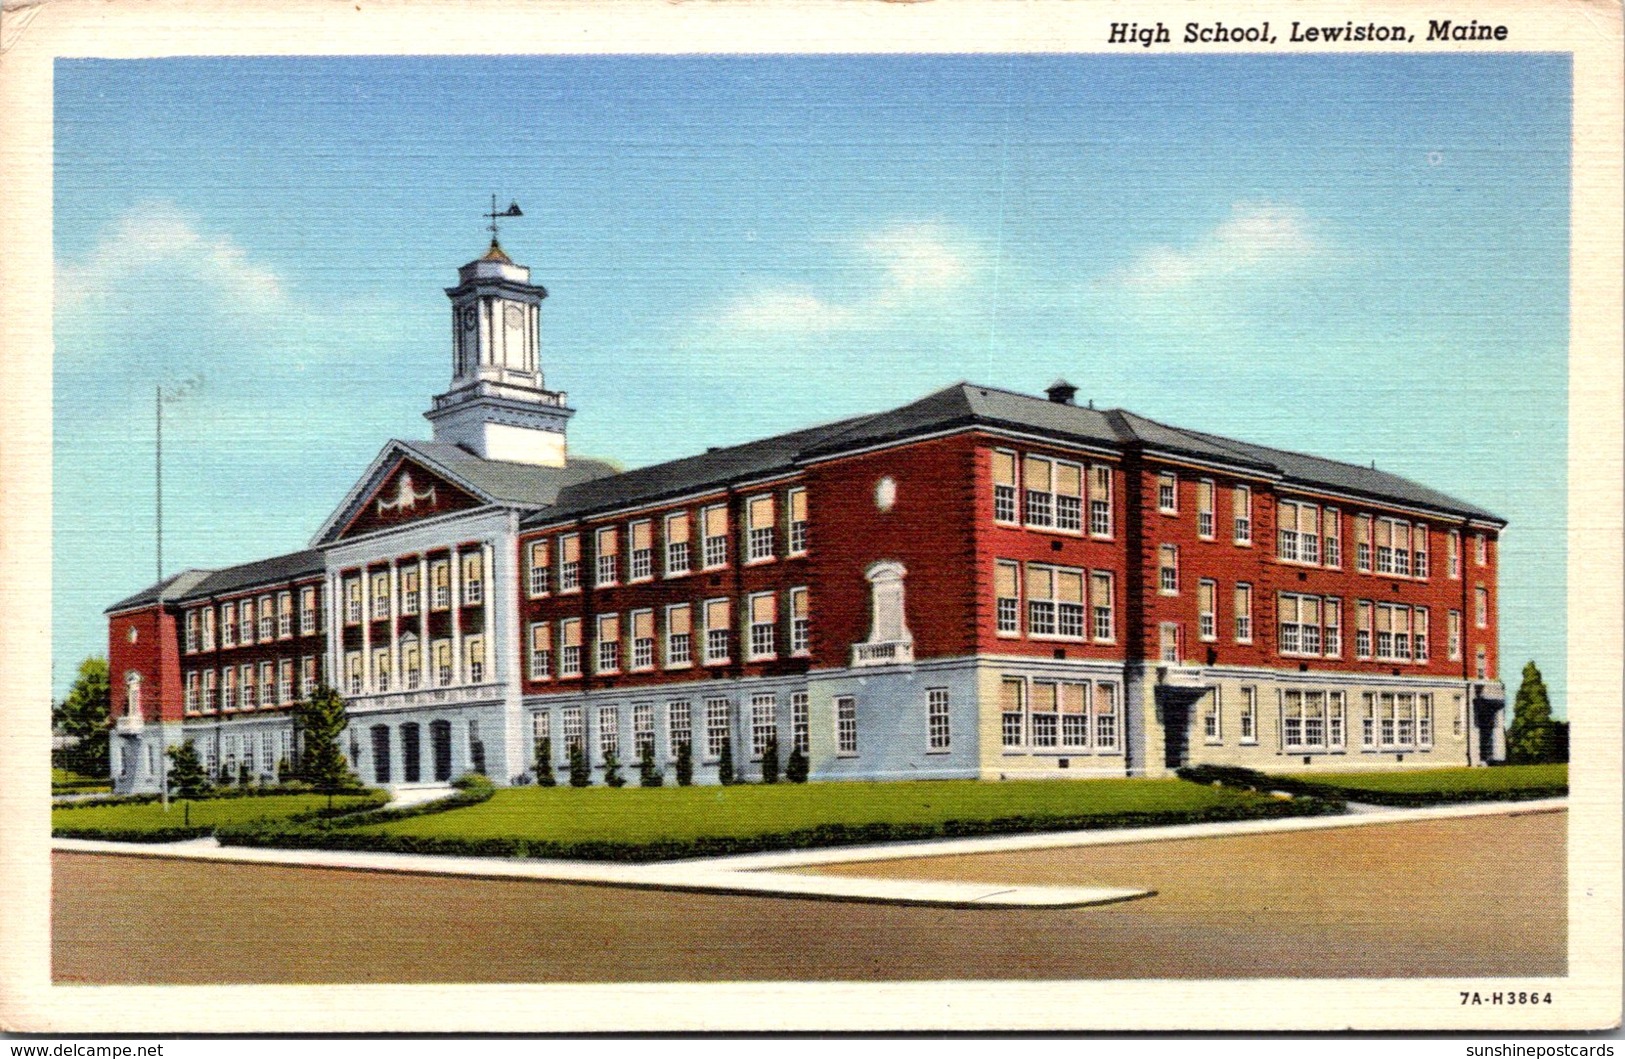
523 382 1505 526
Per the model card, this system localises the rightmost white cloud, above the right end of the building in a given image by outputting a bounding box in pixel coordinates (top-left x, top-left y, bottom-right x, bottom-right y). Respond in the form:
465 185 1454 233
1113 203 1321 294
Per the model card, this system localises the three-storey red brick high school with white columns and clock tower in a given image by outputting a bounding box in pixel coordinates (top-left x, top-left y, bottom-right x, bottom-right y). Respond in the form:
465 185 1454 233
109 235 1505 791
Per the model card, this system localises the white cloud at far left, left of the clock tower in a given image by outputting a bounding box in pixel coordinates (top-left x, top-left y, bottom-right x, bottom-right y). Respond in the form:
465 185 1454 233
57 203 283 310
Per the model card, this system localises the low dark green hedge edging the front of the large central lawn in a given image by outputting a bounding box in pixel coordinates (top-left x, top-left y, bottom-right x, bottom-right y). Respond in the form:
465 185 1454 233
218 793 1344 862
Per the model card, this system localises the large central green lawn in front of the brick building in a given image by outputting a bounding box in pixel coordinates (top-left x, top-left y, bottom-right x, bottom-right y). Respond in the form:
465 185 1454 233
346 780 1269 843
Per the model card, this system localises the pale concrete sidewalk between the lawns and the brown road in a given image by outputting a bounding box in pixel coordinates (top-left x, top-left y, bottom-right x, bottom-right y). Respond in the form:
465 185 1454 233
52 788 1568 908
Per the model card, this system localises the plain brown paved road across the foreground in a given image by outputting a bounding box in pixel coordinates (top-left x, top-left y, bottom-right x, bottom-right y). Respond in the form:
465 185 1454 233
54 812 1568 983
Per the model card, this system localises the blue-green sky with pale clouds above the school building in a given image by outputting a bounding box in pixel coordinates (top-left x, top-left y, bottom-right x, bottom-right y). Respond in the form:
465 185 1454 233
52 54 1571 713
